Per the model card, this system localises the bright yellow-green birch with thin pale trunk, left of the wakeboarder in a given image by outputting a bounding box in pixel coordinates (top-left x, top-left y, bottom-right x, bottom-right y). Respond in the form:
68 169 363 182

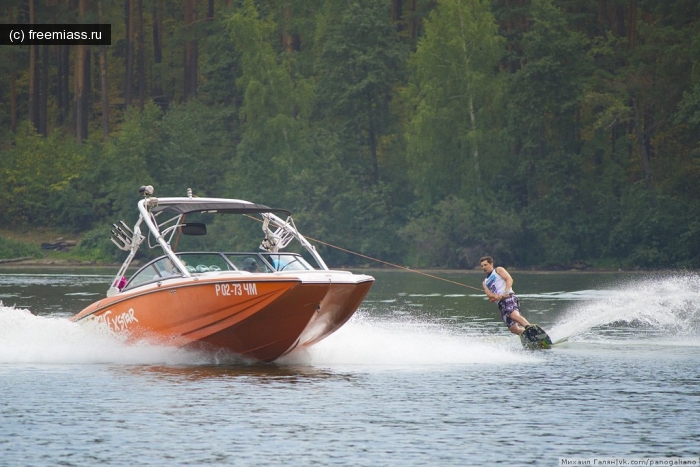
405 0 505 204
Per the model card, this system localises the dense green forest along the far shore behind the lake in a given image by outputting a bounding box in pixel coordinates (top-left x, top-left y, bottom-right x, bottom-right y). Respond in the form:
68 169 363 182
0 0 700 269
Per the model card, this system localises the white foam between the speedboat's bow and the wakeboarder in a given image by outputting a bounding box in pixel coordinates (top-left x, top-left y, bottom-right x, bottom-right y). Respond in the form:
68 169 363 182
280 313 540 369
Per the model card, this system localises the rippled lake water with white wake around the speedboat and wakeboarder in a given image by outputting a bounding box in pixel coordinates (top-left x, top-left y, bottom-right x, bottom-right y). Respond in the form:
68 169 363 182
0 268 700 466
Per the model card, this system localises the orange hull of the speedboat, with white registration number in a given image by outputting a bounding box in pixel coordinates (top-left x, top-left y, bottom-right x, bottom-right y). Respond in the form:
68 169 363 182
72 277 372 362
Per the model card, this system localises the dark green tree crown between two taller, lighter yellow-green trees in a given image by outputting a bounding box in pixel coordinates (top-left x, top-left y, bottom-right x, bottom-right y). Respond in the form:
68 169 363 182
316 0 408 184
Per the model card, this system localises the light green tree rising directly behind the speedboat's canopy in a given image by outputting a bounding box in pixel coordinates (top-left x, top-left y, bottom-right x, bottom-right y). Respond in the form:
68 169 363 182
226 1 313 203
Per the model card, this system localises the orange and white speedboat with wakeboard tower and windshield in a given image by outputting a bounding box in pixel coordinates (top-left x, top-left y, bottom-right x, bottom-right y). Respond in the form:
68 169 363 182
71 186 374 362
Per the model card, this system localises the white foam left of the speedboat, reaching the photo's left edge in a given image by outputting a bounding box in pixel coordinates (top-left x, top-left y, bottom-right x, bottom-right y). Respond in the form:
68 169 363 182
0 305 207 365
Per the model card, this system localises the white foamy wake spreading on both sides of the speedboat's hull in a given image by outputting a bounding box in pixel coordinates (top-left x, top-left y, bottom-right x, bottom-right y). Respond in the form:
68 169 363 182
0 305 538 370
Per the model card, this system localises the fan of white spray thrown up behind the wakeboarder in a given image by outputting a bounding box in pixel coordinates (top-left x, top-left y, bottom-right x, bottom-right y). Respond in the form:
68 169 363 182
549 274 700 344
